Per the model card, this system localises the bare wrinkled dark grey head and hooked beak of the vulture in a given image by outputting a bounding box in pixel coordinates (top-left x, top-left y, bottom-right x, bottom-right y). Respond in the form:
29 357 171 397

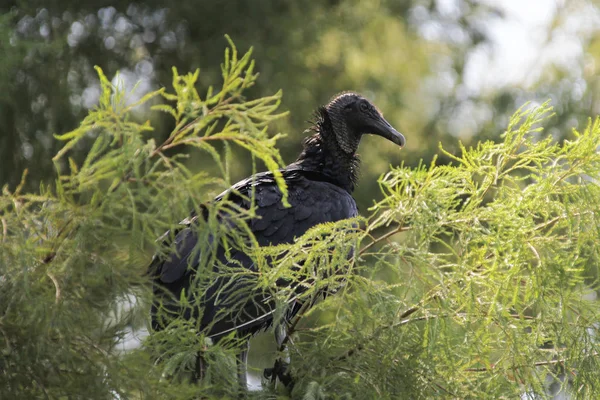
325 92 406 154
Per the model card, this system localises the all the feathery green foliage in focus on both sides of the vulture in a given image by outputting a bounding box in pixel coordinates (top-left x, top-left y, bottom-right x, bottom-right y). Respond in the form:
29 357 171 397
0 38 600 399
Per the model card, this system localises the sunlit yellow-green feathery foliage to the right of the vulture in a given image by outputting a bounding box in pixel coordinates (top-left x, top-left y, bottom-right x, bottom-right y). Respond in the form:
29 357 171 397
292 105 600 398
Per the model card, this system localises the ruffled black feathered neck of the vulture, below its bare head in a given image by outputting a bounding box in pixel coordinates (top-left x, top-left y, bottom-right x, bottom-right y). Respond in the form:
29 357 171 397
294 108 360 193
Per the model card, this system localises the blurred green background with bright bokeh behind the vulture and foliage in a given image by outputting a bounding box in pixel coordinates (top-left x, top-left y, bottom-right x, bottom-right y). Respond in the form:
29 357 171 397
0 0 600 213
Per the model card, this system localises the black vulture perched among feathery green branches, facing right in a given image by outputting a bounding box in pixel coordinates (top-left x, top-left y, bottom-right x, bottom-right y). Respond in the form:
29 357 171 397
149 93 405 388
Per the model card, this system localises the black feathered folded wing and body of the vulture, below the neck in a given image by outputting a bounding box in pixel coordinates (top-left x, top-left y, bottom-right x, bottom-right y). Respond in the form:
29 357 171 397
150 169 357 338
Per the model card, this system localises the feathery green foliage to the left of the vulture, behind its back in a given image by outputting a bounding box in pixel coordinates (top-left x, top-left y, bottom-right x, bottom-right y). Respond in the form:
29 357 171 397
0 39 282 398
